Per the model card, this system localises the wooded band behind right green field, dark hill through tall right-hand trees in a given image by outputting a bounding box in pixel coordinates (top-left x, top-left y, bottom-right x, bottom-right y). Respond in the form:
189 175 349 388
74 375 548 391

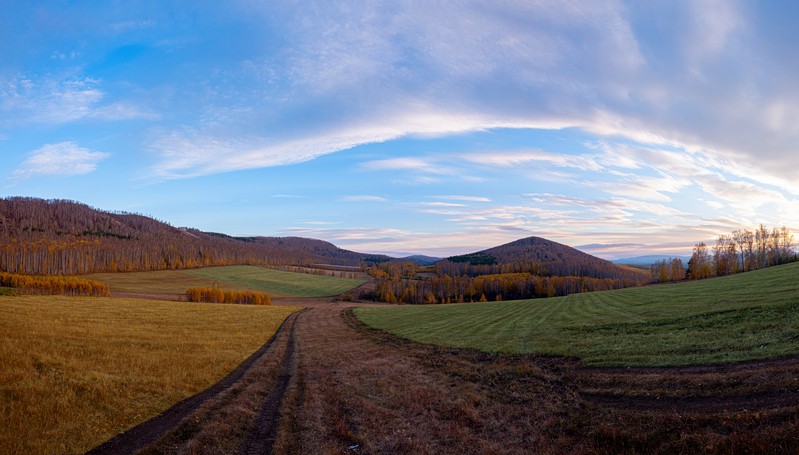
369 232 797 304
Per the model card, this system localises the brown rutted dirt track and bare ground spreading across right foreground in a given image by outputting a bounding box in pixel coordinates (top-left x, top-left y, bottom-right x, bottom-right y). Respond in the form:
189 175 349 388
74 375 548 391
87 299 799 454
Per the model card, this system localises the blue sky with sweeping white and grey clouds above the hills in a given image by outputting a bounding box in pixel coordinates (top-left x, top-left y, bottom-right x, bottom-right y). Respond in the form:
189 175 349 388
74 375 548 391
0 0 799 259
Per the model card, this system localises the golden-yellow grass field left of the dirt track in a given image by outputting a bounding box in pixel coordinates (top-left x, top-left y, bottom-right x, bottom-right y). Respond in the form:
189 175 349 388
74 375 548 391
0 296 298 454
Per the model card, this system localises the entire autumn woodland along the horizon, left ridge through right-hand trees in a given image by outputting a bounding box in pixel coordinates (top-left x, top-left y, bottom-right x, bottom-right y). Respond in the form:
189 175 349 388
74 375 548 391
0 197 797 304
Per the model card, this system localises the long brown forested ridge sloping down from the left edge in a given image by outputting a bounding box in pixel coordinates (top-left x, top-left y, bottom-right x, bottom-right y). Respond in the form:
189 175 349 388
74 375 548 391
0 197 388 275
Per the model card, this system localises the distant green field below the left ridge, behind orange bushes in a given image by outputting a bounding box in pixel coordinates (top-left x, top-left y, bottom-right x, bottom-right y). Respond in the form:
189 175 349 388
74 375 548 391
85 265 363 297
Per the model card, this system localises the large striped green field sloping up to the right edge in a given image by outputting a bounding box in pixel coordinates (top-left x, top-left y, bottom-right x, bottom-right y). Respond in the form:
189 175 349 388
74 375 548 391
355 263 799 365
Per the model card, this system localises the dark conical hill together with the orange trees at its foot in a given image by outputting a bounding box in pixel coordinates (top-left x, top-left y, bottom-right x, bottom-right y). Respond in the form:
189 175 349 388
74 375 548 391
368 237 650 304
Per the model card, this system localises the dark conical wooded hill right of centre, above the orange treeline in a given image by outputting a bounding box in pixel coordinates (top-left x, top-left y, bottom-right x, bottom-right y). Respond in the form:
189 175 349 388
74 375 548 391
439 237 648 281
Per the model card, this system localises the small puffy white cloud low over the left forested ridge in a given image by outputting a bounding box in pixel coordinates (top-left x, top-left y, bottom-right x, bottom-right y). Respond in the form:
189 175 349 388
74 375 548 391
13 142 111 179
